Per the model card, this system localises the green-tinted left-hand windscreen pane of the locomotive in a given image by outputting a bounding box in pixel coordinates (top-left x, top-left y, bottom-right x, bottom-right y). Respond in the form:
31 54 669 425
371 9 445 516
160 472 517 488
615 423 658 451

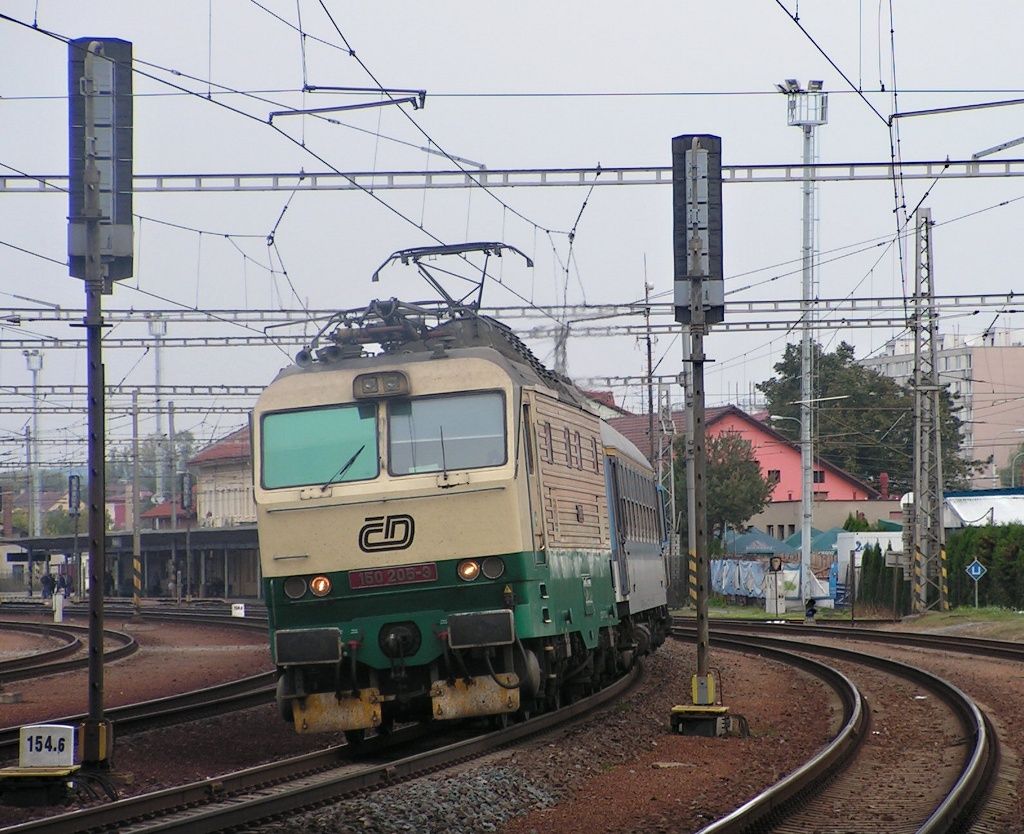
260 403 380 490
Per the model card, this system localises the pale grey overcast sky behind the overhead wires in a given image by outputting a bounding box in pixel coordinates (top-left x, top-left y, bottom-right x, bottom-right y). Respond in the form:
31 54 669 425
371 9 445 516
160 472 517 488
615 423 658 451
0 0 1024 464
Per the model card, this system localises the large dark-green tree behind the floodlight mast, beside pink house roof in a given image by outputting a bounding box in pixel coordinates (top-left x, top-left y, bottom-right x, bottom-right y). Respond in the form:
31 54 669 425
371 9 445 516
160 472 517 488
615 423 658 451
758 342 981 494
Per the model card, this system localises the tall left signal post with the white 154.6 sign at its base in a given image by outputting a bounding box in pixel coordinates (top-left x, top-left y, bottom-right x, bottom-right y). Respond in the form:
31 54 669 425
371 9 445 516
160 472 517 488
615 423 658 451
0 38 133 805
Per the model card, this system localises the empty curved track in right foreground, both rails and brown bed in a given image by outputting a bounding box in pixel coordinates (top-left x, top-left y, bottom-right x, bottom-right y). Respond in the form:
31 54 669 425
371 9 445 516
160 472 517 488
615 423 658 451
673 621 998 834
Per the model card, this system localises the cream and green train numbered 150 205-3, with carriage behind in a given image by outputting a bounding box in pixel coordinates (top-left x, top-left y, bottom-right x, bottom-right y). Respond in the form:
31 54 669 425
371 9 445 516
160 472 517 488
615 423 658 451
252 246 668 740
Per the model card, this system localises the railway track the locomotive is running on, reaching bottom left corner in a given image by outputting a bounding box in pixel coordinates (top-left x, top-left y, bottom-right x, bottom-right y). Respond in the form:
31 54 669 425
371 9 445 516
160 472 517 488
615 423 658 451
3 667 641 834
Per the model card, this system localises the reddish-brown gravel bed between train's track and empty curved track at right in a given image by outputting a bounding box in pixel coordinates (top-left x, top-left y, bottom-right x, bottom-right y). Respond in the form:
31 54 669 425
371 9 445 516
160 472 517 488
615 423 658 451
251 641 838 834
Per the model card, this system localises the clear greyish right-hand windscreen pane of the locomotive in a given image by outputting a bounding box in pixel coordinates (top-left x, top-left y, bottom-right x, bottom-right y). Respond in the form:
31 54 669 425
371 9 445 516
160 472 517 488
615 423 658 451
388 391 508 475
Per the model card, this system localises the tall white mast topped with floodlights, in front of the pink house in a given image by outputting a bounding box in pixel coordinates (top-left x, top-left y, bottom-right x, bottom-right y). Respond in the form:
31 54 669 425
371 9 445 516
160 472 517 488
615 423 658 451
776 78 828 604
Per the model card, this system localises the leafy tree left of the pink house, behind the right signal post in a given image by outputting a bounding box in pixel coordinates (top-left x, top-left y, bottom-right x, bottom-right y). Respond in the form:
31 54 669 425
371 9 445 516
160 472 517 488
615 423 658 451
675 431 775 539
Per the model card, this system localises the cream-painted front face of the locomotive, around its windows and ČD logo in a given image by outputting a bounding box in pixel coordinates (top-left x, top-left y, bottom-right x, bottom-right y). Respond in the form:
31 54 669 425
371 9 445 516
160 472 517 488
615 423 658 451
253 347 555 576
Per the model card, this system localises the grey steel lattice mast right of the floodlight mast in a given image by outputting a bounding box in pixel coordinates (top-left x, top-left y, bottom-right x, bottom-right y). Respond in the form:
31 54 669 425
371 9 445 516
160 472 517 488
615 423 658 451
910 208 949 612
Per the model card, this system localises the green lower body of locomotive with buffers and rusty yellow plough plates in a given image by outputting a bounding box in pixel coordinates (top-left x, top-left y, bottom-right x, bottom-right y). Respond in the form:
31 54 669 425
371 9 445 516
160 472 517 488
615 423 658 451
264 550 618 732
